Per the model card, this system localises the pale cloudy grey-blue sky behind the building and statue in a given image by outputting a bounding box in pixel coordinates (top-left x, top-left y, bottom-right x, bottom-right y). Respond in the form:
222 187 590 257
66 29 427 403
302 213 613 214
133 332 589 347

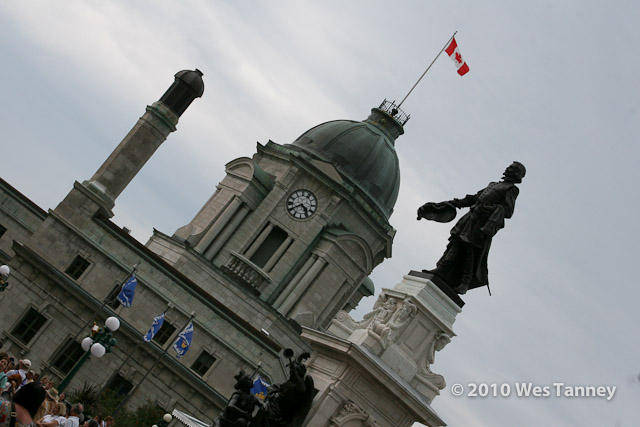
0 0 640 427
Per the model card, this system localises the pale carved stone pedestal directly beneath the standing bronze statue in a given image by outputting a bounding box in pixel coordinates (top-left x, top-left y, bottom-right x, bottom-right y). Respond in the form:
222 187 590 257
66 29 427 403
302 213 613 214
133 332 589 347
328 271 464 402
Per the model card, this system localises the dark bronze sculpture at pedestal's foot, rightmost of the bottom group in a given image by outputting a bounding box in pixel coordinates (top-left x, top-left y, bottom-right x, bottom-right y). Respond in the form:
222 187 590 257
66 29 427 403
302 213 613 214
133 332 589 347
251 349 314 427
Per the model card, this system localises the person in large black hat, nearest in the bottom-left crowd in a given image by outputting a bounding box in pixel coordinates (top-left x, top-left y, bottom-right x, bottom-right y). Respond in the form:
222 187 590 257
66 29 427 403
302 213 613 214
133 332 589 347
0 383 46 427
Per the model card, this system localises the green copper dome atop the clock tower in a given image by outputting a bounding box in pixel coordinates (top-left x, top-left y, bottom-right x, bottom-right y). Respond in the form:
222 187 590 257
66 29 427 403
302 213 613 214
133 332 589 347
290 108 404 219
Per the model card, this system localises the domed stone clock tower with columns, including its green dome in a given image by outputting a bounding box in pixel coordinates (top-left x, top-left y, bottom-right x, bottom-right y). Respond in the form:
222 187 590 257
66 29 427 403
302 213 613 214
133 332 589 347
147 101 408 329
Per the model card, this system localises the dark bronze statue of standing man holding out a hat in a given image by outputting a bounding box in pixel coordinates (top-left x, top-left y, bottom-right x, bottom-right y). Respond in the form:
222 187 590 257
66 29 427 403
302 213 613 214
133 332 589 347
418 162 526 294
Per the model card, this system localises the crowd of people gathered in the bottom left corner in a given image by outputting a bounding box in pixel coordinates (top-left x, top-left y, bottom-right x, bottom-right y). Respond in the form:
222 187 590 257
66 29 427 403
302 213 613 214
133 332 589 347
0 352 115 427
